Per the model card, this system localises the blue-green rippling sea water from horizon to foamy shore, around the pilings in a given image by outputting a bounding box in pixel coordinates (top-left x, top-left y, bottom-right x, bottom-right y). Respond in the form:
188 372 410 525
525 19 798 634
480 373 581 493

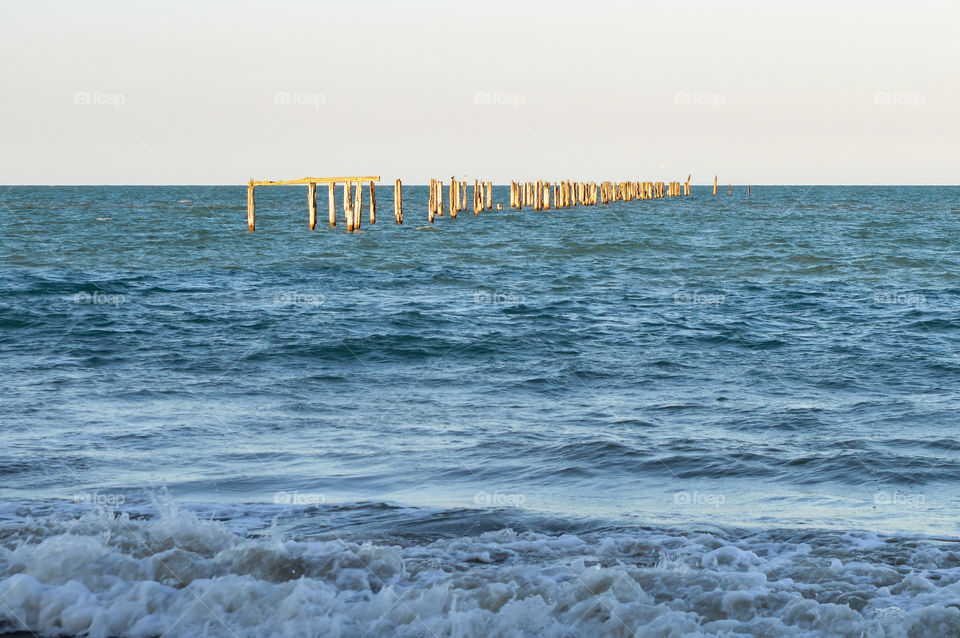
0 186 960 638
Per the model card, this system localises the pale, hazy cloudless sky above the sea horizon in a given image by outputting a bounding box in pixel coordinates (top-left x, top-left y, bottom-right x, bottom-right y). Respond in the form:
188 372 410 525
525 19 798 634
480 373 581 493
0 0 960 184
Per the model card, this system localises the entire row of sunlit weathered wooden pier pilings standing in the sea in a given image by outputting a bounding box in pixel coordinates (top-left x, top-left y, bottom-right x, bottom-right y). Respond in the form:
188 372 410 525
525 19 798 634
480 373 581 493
247 175 750 231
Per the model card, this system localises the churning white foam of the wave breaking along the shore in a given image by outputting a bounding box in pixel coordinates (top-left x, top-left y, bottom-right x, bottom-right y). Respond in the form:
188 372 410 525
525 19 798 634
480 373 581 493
0 506 960 638
